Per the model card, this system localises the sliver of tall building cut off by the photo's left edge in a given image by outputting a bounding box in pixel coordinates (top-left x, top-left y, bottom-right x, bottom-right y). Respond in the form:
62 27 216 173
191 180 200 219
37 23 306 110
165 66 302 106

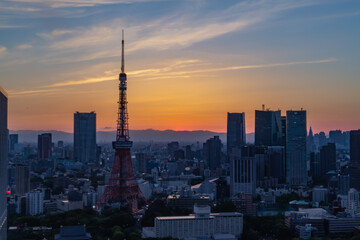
0 87 9 239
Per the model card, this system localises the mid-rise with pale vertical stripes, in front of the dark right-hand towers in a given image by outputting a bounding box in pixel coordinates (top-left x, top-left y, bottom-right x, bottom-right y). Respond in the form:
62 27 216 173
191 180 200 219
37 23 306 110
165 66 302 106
230 145 257 197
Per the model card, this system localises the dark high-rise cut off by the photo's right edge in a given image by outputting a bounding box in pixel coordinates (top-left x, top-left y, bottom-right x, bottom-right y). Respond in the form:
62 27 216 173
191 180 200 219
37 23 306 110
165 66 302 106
348 129 360 191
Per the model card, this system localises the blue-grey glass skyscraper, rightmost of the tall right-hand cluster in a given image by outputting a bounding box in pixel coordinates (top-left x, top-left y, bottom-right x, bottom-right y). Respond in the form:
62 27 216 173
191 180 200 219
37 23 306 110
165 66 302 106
286 110 307 186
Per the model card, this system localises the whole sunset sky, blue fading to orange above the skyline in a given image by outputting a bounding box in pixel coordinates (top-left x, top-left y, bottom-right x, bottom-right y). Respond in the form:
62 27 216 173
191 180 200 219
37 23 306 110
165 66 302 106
0 0 360 132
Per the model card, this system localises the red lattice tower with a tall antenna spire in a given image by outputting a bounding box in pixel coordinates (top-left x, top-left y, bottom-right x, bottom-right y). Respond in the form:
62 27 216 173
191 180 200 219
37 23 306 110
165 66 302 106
95 31 146 214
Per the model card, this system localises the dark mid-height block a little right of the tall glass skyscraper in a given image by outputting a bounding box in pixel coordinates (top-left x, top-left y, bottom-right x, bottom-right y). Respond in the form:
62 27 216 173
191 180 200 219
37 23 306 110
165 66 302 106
320 143 336 175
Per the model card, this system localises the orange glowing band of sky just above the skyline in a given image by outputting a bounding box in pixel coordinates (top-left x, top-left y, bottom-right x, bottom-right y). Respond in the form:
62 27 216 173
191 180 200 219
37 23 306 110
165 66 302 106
4 53 360 133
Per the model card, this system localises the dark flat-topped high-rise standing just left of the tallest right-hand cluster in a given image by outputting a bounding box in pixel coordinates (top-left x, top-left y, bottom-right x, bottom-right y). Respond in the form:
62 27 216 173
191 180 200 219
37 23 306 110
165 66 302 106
226 113 246 154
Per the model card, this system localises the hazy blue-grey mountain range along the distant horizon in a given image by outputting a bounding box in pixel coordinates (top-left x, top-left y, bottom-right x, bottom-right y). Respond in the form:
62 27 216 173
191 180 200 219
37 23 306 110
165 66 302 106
10 129 254 143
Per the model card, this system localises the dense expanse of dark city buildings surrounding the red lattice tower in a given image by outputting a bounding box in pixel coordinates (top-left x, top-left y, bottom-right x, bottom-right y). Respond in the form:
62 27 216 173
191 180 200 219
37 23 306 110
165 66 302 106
0 80 360 239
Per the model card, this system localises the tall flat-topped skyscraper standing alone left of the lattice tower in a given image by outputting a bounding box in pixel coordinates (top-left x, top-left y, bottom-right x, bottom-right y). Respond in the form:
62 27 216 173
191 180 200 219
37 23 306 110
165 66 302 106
74 112 96 163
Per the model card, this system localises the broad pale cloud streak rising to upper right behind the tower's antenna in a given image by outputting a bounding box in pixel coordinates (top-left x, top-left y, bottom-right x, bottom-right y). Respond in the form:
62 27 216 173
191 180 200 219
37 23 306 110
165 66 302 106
38 1 316 54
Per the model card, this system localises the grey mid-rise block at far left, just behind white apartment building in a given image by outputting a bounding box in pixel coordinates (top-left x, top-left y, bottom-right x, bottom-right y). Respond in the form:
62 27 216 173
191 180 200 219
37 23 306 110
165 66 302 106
15 164 30 196
